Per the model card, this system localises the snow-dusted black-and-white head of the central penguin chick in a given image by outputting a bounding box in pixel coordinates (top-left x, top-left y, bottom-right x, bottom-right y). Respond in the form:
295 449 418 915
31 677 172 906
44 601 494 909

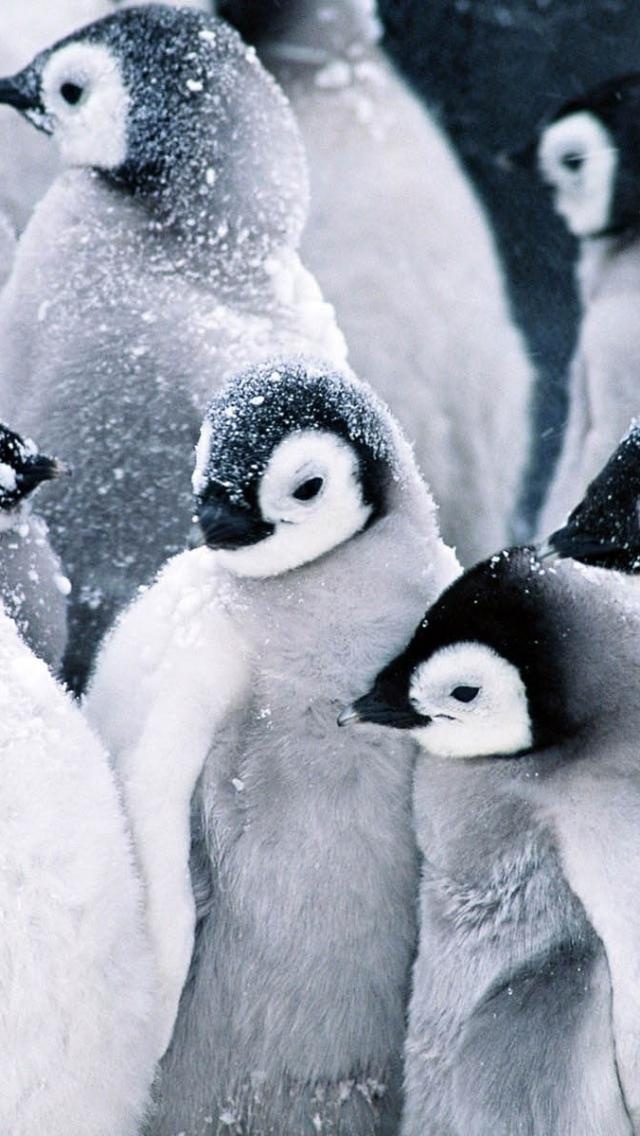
193 361 396 577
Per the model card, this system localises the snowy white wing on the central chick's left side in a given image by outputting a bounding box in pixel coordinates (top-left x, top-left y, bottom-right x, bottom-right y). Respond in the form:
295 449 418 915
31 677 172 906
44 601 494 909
85 549 248 1045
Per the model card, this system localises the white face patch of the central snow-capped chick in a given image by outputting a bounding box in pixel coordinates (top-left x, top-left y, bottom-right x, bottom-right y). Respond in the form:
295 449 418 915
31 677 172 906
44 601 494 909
218 431 372 576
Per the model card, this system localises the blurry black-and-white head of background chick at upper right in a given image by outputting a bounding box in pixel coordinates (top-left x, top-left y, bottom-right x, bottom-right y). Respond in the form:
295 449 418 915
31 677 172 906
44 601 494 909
537 74 640 237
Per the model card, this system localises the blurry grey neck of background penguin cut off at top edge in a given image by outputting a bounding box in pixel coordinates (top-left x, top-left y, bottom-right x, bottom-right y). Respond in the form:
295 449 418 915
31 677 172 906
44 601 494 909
260 0 381 70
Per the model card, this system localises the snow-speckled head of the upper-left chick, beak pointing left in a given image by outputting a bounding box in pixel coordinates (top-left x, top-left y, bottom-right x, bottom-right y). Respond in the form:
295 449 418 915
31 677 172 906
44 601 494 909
0 3 307 240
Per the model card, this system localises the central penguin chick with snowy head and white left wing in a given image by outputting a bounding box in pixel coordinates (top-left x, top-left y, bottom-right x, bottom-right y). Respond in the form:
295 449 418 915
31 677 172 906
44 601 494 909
88 361 458 1136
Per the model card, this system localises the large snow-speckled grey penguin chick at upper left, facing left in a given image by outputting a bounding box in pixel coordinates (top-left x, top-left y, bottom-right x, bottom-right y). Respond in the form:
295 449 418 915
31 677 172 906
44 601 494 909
0 5 344 690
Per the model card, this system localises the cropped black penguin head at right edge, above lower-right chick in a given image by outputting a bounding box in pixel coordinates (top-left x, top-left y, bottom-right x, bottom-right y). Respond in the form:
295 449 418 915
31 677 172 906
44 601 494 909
540 424 640 575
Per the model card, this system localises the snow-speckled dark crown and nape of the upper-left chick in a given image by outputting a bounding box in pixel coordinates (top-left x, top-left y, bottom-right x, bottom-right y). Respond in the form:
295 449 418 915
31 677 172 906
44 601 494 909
32 5 308 256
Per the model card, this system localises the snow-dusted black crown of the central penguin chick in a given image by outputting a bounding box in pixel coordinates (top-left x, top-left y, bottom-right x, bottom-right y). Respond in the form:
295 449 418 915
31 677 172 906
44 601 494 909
193 360 398 506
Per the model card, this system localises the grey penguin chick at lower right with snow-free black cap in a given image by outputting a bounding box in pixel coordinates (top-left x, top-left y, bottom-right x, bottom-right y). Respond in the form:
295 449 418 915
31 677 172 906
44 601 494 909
340 550 640 1136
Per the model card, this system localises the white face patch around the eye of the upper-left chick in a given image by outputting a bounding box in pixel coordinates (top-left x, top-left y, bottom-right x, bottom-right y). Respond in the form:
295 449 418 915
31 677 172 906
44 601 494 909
42 43 130 170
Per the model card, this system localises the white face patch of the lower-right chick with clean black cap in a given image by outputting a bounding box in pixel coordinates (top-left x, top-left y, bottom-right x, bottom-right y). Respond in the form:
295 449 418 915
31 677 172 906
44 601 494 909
409 642 532 758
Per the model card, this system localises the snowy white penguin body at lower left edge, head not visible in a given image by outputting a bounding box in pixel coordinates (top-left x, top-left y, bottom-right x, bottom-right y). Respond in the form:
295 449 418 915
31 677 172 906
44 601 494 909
0 599 159 1136
